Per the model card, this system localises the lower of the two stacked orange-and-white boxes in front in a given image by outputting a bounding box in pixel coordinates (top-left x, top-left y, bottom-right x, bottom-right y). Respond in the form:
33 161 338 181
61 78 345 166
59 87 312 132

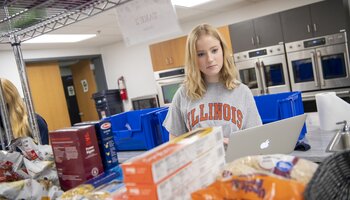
126 143 225 200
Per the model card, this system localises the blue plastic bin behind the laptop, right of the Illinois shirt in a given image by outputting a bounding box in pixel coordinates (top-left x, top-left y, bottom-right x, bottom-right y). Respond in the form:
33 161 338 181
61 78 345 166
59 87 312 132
254 92 306 140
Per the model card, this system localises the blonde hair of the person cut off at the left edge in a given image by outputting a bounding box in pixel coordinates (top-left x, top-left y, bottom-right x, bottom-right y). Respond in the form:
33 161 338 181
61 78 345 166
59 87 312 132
0 78 30 138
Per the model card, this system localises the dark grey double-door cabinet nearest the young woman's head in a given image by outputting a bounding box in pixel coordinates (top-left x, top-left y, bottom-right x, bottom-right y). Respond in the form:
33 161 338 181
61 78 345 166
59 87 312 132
229 13 283 53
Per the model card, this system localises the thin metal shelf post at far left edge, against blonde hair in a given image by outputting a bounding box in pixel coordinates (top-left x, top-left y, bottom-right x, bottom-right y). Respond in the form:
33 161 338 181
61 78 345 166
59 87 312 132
0 79 13 150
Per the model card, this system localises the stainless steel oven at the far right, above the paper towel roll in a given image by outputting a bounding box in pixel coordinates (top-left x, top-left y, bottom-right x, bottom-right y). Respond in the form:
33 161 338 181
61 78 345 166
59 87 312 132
285 32 350 91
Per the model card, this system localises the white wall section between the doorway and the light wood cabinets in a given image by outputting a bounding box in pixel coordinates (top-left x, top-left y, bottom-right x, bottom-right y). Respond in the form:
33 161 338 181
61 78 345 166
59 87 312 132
101 43 157 110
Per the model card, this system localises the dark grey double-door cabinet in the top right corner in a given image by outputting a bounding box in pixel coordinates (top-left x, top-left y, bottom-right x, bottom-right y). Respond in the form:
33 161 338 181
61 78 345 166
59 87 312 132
280 0 348 42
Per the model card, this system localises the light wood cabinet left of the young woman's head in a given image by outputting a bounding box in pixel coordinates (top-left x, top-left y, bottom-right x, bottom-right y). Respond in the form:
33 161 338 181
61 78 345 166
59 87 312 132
149 36 187 71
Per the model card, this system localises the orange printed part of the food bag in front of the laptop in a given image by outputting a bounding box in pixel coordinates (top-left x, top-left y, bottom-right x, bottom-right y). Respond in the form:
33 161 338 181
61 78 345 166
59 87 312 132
191 174 305 200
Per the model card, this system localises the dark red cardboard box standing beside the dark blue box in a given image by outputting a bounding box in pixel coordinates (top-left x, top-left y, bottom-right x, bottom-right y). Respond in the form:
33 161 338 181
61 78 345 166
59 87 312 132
50 125 103 191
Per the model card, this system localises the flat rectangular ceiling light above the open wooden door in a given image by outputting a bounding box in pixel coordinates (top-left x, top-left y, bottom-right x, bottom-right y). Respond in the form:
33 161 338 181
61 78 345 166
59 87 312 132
23 34 96 43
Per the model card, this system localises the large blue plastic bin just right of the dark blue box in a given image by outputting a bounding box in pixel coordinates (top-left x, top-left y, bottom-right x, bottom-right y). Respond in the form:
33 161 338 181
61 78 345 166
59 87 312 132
109 108 163 151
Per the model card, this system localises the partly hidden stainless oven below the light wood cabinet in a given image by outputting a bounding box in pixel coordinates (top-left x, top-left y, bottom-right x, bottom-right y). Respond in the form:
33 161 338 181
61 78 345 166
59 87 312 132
154 67 185 106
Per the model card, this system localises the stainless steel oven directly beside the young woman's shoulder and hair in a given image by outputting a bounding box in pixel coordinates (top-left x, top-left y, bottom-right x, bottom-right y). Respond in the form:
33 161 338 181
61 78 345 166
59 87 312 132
233 44 290 95
